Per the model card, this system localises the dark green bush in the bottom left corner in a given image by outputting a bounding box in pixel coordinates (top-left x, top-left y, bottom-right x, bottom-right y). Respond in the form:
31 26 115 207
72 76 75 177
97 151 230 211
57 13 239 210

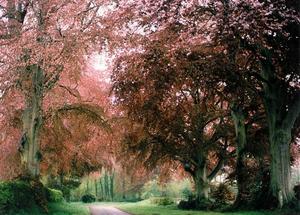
0 181 36 214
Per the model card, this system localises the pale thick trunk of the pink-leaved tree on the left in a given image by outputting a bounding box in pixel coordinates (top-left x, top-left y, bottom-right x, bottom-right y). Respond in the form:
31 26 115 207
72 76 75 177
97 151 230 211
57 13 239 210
20 65 44 178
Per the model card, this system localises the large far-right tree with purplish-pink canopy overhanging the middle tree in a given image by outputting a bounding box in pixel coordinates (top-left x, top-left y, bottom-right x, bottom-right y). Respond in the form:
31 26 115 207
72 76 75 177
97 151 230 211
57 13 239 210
110 0 300 206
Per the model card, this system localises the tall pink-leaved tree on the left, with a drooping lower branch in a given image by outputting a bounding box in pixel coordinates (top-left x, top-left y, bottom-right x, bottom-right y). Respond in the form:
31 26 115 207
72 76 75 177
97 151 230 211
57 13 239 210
0 0 116 178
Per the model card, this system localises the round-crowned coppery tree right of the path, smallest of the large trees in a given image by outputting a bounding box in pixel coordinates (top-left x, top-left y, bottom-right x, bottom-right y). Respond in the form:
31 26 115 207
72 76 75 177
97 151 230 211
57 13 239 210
113 39 236 202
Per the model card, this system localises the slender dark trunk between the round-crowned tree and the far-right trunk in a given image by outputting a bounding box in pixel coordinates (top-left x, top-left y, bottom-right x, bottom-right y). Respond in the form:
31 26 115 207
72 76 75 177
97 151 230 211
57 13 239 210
231 106 248 207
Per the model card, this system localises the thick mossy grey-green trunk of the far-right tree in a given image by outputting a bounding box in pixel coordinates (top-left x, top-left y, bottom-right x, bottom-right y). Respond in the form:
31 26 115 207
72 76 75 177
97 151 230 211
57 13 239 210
261 53 300 207
